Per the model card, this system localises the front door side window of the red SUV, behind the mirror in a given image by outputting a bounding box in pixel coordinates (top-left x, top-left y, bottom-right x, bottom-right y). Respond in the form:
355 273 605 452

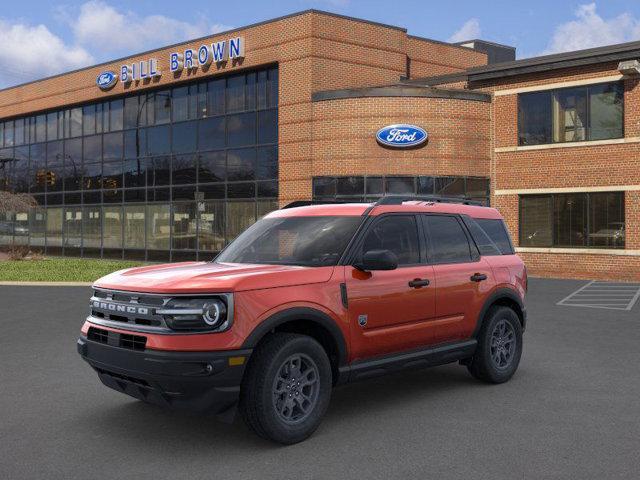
362 215 420 265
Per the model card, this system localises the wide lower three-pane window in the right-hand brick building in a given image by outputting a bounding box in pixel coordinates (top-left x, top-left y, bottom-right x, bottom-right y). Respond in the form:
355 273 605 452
520 192 625 248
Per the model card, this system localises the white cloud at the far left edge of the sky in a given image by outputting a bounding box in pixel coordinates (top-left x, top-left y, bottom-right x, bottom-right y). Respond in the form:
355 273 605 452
0 20 94 88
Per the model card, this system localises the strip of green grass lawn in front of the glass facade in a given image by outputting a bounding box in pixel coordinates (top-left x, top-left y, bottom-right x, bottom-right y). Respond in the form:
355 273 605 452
0 258 144 282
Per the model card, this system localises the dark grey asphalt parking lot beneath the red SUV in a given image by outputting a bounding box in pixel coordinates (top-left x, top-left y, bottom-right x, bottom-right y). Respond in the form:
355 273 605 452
0 279 640 480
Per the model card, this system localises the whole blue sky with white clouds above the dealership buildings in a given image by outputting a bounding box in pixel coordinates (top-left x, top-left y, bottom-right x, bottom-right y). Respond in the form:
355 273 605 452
0 0 640 88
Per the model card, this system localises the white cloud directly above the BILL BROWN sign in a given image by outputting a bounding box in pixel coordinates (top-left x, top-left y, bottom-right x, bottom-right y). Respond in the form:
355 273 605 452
69 0 230 53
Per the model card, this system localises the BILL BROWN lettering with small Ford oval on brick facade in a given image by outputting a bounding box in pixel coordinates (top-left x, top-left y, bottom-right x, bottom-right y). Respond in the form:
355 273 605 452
96 37 244 90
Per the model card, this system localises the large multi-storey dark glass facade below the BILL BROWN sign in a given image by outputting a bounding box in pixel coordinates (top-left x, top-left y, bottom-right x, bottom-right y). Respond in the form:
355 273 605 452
0 67 278 260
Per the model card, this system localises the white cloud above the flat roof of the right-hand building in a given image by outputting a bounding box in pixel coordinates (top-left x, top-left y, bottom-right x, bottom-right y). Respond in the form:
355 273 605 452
542 2 640 54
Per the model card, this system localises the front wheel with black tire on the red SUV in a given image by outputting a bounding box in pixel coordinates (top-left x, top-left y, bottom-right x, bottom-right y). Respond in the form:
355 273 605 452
240 333 333 445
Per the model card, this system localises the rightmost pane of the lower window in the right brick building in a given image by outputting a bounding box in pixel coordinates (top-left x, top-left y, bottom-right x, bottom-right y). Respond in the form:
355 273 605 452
589 192 625 248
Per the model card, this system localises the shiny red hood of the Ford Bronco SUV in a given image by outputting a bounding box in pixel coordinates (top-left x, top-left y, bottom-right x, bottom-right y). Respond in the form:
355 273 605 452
94 262 333 293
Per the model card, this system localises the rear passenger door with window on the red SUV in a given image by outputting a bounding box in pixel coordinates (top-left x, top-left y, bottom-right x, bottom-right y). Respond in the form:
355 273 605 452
421 215 495 343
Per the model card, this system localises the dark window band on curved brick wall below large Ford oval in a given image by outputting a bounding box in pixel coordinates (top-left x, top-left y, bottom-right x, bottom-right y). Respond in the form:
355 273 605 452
313 176 490 205
